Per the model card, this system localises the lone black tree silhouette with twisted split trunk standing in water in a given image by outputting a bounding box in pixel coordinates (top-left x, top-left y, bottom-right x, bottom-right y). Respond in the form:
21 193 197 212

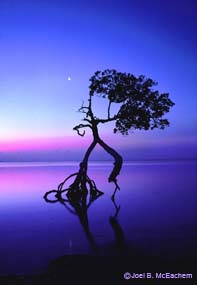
45 69 174 197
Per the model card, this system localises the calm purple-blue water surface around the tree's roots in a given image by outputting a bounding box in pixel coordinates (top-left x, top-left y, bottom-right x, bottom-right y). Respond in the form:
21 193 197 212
0 161 197 275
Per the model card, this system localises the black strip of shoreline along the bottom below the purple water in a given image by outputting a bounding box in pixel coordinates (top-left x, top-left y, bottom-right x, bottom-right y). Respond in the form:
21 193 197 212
0 255 197 285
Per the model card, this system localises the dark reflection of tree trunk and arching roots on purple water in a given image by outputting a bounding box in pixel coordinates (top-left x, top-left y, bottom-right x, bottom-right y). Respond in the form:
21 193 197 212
44 178 125 255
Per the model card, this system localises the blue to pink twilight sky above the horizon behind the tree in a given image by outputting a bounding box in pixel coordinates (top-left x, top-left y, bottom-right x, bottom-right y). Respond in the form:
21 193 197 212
0 0 197 161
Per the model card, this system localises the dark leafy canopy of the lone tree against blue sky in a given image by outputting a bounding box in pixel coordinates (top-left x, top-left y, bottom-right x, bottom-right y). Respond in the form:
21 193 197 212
87 69 174 135
